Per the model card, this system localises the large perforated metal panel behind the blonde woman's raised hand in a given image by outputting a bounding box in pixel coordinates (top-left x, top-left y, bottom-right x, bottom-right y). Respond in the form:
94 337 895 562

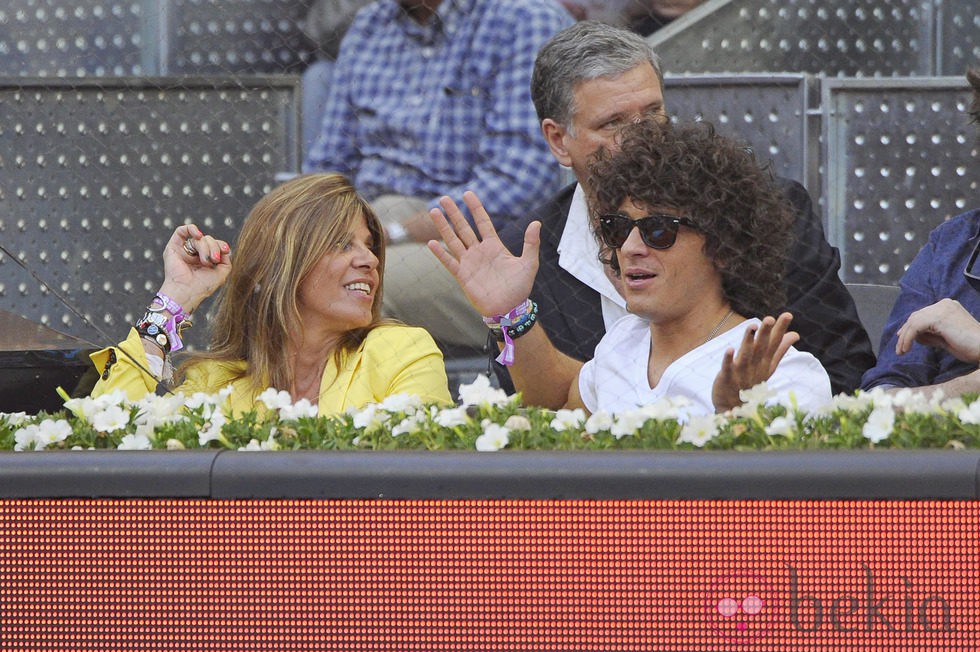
0 77 297 344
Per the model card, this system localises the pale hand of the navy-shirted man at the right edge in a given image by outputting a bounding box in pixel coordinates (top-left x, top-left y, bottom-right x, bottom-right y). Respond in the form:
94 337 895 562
895 299 980 363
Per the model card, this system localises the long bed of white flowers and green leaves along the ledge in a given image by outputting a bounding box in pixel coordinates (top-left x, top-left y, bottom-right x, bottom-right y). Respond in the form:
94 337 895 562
0 376 980 451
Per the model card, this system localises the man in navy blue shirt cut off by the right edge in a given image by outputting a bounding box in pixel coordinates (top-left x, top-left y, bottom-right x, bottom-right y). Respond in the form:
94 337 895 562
861 69 980 396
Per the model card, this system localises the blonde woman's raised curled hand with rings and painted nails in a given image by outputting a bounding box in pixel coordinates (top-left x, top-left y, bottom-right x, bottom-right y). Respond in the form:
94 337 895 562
160 224 231 314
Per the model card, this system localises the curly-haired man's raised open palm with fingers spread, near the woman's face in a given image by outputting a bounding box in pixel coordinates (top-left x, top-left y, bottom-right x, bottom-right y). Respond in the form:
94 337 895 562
428 191 541 317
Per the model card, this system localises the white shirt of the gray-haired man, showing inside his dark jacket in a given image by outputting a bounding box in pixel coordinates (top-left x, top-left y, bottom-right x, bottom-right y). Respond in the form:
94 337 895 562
558 185 627 331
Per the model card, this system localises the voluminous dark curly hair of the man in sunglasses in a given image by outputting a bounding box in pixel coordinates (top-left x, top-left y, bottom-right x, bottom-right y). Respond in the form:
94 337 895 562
588 120 794 317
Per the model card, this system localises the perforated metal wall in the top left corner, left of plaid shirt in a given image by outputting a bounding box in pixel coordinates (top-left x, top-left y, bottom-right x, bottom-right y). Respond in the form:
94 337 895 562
0 0 313 77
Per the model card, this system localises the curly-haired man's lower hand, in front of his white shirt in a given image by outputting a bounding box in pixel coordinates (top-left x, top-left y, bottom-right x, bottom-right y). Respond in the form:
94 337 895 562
711 312 800 412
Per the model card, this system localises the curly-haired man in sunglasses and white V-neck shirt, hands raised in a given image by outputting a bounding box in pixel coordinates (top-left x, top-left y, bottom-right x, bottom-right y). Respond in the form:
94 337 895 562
429 119 831 416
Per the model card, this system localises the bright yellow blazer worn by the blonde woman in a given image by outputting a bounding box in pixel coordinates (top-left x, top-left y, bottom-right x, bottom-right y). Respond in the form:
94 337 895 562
90 325 452 415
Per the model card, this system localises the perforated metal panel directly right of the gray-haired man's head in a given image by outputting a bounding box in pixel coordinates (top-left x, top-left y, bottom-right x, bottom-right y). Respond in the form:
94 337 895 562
664 74 819 191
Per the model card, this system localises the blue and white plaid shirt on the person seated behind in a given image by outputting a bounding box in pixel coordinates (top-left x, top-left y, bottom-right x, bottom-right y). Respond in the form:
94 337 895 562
303 0 574 228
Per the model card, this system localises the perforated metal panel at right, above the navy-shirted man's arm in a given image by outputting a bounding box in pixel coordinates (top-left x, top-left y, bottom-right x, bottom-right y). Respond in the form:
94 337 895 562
822 77 980 284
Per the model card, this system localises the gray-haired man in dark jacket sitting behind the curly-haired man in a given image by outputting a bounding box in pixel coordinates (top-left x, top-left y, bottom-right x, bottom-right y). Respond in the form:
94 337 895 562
496 21 874 407
